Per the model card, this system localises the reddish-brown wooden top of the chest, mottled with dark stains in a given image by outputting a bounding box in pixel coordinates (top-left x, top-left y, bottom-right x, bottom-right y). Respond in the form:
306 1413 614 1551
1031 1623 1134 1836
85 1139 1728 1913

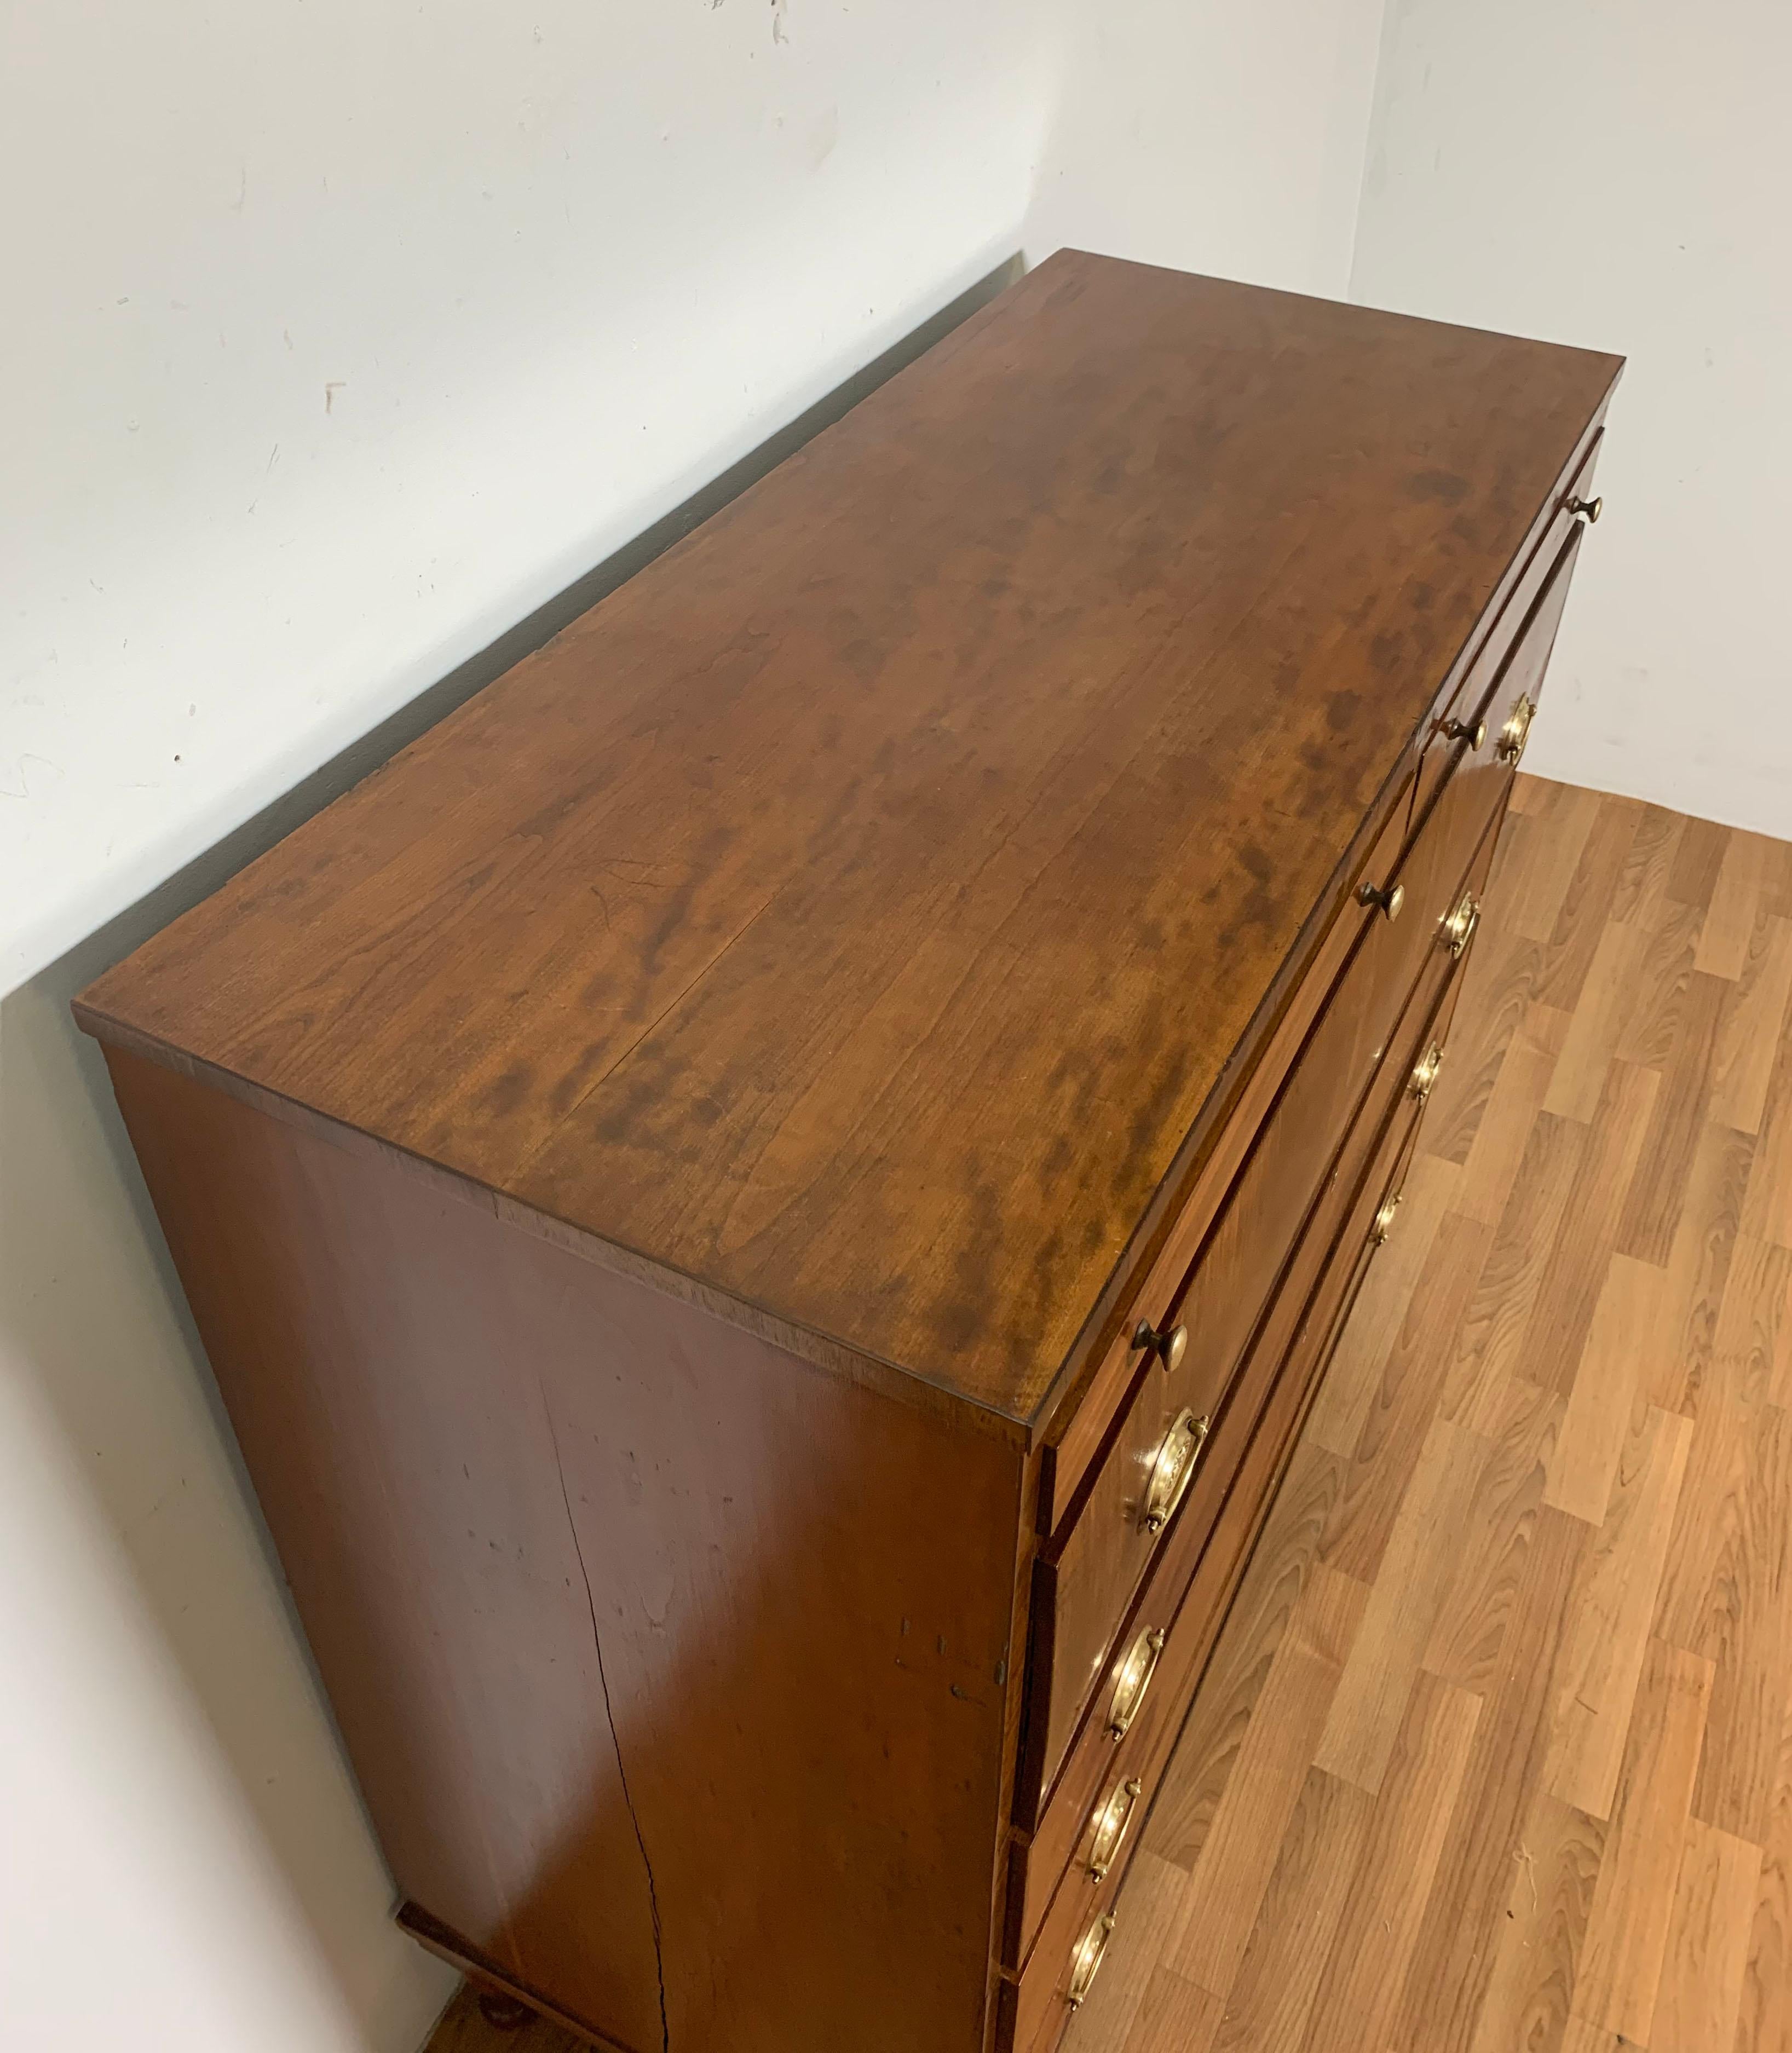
80 252 1620 1429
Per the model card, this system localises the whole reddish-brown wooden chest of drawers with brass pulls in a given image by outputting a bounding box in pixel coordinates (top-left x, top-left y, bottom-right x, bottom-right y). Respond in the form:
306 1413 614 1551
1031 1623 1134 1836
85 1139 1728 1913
78 252 1620 2053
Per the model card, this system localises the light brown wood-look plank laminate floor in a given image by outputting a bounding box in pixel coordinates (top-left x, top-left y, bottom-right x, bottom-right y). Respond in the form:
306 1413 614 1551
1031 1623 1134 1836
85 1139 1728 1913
431 778 1792 2053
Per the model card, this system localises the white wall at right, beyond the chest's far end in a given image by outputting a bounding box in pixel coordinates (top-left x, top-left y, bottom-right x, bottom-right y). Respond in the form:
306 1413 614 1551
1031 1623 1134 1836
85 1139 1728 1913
1351 0 1792 835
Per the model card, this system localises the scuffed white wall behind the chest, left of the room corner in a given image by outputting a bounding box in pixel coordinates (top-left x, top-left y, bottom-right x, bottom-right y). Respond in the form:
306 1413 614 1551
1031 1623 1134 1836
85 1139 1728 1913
0 0 1373 2053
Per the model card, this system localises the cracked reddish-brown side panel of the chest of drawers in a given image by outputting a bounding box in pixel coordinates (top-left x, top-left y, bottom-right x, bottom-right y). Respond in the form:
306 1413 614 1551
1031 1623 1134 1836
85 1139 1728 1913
111 1051 1020 2053
